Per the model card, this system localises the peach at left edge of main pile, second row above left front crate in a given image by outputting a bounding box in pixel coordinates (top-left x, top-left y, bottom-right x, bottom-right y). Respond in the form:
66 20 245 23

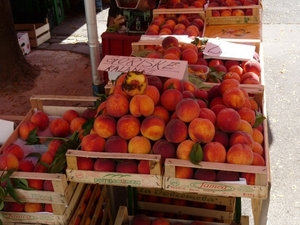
93 114 117 138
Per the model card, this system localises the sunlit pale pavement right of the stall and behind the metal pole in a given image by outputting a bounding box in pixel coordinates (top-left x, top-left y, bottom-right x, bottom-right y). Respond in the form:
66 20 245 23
32 0 300 225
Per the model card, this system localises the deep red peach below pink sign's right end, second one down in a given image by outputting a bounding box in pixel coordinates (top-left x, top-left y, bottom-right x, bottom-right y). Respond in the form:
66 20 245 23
160 89 183 112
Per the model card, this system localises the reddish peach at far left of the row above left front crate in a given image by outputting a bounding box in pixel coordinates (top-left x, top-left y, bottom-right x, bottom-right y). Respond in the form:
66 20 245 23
81 134 106 152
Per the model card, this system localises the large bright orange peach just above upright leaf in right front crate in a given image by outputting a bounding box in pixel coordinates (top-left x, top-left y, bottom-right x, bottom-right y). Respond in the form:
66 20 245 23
188 118 215 143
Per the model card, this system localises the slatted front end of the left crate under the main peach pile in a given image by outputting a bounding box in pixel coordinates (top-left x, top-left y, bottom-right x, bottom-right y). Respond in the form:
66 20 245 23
66 150 162 188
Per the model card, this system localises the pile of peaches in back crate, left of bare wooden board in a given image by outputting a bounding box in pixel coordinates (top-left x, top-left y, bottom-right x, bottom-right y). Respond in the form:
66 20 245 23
145 13 204 37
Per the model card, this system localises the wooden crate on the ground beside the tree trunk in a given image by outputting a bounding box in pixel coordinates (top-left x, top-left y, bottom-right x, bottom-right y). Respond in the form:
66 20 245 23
15 19 51 48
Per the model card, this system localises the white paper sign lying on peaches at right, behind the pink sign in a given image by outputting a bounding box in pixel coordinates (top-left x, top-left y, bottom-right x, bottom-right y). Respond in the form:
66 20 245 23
203 39 255 60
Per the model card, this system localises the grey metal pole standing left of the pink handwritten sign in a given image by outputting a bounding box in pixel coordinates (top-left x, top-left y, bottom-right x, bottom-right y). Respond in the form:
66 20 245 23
84 0 105 96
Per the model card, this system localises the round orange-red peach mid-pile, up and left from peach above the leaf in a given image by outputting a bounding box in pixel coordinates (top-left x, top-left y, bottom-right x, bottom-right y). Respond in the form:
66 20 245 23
175 98 200 123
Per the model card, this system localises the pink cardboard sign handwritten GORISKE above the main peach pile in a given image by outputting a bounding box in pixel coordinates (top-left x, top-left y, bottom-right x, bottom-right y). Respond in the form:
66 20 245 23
98 55 188 80
